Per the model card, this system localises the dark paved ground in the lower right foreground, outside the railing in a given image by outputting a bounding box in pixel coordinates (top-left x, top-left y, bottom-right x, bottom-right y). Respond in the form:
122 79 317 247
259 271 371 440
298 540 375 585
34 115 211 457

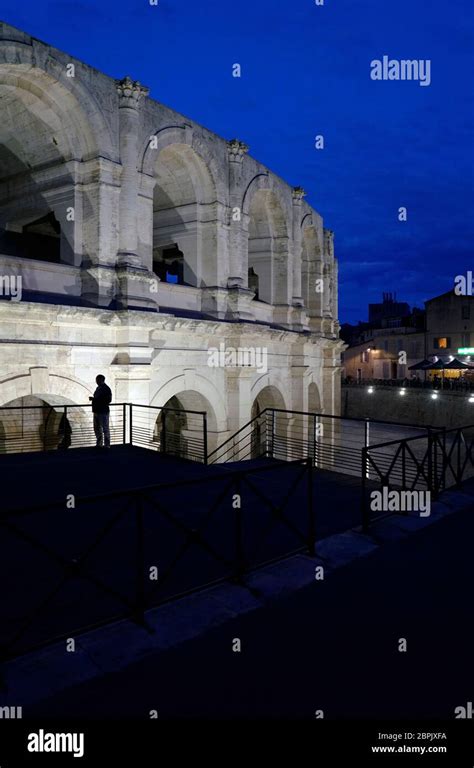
29 506 474 720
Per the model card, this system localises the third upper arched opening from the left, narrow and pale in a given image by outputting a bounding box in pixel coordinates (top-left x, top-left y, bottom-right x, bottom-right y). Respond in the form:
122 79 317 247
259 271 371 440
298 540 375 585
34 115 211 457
248 189 289 304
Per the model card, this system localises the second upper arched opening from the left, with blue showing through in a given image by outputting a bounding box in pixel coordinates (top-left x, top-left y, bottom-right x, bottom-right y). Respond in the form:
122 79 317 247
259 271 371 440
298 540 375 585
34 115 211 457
153 144 217 287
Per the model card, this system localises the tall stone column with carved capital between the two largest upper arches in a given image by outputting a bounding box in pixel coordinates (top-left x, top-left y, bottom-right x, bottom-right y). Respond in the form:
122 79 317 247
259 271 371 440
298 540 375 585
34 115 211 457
116 77 149 267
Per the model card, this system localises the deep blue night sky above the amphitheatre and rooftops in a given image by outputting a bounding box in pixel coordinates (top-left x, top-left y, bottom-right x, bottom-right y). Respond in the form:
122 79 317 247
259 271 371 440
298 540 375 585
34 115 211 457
0 0 474 322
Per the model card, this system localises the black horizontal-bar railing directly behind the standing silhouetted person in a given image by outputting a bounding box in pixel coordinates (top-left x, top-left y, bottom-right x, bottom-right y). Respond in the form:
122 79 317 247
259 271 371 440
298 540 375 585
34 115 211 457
0 403 207 463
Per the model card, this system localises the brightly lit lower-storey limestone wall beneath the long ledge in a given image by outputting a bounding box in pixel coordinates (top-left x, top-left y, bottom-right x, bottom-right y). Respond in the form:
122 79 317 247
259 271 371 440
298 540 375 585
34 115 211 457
0 302 340 442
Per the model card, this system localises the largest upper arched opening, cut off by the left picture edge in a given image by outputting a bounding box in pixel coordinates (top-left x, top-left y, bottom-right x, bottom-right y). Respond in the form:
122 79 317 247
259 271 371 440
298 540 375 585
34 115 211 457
0 64 94 274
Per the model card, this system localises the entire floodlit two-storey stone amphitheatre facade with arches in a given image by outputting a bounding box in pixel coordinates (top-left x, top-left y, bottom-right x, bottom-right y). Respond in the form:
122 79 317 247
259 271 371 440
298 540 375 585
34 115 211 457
0 23 342 446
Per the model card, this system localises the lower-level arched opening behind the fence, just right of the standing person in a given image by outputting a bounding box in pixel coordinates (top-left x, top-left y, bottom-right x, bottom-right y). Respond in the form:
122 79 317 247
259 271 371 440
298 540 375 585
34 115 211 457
153 390 216 461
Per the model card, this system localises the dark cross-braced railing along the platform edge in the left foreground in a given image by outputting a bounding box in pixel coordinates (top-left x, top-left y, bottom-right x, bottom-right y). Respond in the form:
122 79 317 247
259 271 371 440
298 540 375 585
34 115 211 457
0 461 316 661
